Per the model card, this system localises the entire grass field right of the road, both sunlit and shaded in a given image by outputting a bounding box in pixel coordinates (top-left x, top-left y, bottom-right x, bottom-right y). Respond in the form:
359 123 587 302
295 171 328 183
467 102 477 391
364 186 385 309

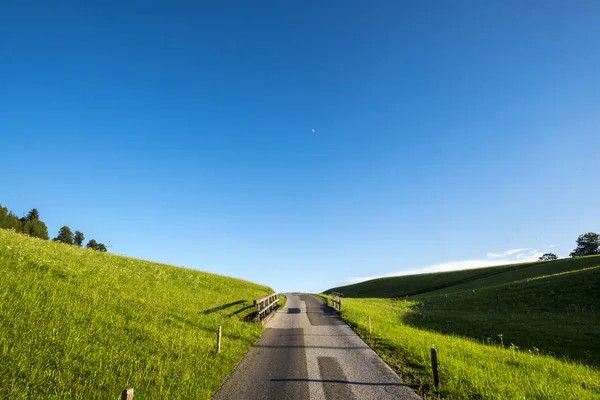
326 256 600 400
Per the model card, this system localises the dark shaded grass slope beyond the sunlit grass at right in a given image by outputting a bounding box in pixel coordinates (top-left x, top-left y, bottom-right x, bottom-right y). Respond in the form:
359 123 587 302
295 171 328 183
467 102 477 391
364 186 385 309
403 259 600 367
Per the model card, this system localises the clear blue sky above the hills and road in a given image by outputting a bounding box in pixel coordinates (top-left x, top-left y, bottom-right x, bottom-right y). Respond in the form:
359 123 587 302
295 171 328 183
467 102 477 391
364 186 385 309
0 1 600 291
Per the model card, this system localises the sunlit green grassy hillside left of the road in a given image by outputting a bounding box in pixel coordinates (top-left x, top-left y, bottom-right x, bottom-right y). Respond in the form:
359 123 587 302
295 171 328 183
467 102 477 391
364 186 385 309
0 229 271 399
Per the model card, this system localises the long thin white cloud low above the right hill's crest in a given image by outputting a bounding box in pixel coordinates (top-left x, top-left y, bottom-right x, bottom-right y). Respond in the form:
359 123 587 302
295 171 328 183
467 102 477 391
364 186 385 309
346 247 543 283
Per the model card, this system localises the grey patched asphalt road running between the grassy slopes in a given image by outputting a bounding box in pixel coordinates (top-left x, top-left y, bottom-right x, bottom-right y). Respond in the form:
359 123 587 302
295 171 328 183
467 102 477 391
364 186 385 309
214 294 421 400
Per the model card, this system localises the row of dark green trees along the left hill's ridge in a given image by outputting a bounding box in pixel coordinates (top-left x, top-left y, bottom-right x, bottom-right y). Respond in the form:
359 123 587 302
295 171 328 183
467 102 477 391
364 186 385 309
0 205 107 252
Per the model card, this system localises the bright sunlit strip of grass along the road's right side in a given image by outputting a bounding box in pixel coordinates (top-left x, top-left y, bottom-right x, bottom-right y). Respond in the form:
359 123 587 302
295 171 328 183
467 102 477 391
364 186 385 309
332 298 600 400
